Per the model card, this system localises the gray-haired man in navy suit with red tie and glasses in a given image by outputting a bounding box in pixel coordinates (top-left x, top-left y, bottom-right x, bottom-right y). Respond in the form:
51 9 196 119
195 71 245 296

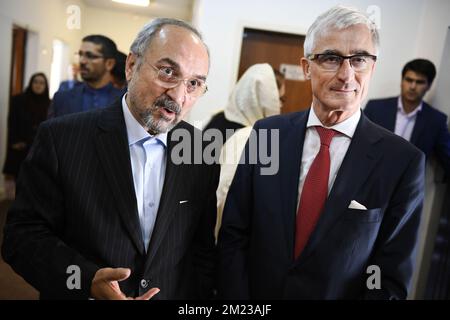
218 6 424 299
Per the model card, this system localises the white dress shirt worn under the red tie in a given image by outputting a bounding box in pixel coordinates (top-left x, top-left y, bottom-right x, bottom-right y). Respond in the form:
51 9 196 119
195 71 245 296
297 107 361 209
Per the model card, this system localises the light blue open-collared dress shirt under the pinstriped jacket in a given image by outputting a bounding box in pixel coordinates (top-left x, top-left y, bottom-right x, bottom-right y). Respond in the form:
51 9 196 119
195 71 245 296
122 95 167 250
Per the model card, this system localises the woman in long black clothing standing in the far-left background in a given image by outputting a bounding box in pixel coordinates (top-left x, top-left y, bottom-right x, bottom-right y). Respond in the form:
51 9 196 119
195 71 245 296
3 73 50 198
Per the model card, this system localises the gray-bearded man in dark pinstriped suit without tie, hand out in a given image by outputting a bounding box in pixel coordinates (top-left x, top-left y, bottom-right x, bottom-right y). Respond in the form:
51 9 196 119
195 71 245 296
2 19 219 299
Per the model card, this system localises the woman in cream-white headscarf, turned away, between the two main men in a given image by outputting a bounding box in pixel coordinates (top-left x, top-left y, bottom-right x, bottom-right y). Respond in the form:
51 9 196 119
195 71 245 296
215 63 285 239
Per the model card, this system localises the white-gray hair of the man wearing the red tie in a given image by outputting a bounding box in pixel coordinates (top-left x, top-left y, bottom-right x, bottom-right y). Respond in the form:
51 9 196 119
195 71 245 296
303 6 380 57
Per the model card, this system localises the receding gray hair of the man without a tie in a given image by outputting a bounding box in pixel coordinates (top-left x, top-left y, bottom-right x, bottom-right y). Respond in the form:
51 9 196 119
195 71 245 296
130 18 209 62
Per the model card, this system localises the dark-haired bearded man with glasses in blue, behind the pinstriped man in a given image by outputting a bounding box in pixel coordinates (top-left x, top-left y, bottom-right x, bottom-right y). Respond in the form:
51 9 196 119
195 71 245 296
49 35 125 118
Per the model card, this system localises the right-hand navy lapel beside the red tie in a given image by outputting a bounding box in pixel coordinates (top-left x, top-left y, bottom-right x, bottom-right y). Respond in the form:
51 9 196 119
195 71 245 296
297 114 381 263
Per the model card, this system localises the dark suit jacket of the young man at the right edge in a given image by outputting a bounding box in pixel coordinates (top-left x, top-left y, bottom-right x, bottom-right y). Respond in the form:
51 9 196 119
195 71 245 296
364 97 450 175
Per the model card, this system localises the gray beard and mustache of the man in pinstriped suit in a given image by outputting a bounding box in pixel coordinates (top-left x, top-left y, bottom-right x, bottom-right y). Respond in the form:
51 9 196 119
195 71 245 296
139 95 181 135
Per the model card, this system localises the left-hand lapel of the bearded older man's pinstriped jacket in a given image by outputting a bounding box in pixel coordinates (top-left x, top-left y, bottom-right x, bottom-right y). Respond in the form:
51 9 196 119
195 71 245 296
95 101 144 254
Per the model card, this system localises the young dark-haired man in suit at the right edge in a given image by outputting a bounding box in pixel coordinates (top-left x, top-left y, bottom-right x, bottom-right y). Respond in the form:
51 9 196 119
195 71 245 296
364 59 450 176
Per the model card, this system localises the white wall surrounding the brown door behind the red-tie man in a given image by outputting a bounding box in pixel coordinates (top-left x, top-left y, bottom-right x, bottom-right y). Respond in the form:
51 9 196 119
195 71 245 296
190 0 450 122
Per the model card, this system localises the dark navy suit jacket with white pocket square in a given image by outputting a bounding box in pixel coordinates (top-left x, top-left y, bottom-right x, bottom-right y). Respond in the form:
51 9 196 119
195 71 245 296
218 112 425 299
